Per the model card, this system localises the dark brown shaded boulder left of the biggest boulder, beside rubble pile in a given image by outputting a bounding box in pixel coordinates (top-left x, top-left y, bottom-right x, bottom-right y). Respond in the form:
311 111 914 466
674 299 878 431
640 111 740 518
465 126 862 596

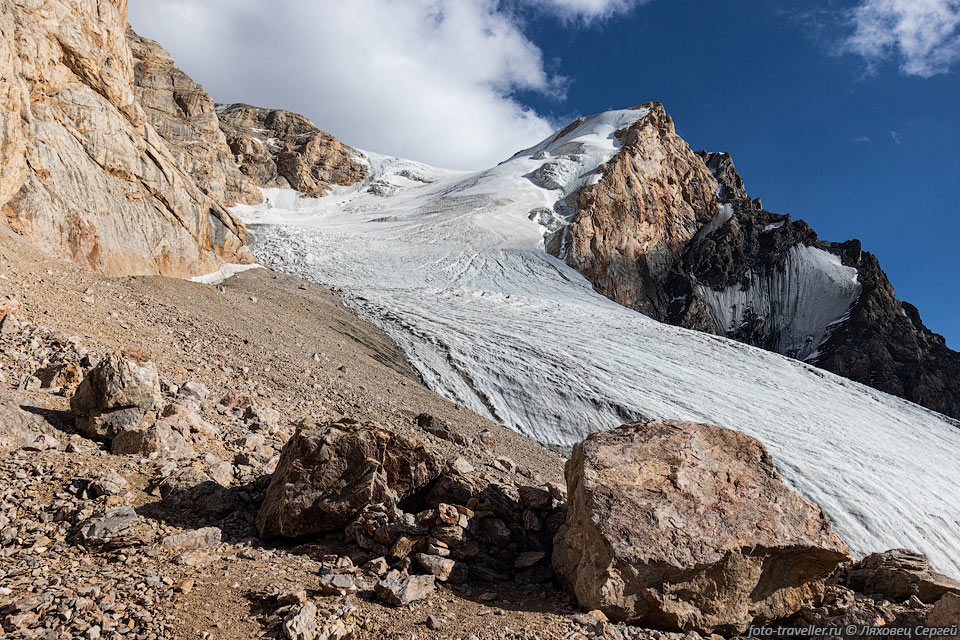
257 422 444 538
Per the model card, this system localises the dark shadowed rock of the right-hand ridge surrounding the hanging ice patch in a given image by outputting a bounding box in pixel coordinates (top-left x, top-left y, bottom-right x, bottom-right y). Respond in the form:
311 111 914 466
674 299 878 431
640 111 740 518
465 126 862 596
664 154 960 418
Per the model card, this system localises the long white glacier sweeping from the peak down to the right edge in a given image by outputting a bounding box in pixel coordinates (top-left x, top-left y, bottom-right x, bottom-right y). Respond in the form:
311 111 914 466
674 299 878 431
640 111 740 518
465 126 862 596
236 111 960 575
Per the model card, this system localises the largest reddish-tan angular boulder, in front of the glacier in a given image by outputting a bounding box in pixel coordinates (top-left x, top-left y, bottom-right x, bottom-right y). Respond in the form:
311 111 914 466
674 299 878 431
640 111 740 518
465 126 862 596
553 421 849 633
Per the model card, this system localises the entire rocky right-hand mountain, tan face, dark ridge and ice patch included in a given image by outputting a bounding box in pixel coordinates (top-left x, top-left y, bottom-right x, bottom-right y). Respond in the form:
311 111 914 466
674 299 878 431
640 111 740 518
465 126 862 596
564 119 960 417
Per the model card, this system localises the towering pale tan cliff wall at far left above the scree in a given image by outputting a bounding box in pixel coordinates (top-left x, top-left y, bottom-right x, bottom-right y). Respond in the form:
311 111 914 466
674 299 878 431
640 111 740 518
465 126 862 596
0 0 253 276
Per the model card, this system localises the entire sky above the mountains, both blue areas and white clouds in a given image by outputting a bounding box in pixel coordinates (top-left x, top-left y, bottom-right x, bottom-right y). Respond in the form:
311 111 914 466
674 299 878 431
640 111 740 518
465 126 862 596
130 0 960 349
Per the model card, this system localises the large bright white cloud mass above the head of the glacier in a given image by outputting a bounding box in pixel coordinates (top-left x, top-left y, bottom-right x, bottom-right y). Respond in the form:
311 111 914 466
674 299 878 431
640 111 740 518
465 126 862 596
130 0 576 168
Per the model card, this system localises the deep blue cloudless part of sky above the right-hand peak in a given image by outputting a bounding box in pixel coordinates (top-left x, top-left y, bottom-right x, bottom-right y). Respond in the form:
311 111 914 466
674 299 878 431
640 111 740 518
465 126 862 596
523 0 960 349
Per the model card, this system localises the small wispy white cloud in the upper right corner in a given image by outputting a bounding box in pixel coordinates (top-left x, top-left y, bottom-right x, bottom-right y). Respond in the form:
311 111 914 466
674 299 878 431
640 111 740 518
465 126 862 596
844 0 960 78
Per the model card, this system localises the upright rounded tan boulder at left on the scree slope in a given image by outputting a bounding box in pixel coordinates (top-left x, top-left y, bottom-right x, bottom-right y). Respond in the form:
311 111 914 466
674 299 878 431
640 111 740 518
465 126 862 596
70 353 161 441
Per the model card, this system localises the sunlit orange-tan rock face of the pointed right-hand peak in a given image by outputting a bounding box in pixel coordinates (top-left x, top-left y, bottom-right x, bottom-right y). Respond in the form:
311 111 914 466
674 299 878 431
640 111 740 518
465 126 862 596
566 103 719 317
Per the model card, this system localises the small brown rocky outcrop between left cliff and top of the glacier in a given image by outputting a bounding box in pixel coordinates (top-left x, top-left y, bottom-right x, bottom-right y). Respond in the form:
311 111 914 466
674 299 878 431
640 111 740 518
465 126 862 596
218 104 368 197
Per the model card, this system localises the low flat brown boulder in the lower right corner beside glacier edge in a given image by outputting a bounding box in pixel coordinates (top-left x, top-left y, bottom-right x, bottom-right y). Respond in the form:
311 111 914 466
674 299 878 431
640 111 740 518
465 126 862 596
837 549 960 604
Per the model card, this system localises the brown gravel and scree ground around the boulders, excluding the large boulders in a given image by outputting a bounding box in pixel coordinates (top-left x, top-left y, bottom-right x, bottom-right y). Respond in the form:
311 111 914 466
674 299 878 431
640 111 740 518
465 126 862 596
0 229 652 640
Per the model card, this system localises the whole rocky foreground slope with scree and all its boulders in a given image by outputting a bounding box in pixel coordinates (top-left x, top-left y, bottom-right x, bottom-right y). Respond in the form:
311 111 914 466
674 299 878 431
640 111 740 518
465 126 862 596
0 216 960 640
